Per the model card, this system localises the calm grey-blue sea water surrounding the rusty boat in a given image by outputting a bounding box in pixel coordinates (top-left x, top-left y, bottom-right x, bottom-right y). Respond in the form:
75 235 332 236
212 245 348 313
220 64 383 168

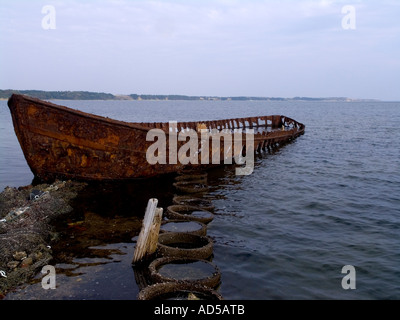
0 101 400 299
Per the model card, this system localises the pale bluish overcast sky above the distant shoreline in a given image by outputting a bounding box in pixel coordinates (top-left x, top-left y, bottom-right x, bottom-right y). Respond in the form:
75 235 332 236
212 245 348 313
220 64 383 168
0 0 400 101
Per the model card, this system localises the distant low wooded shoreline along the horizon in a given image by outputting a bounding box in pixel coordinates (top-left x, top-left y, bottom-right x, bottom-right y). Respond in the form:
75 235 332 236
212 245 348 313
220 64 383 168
0 89 381 102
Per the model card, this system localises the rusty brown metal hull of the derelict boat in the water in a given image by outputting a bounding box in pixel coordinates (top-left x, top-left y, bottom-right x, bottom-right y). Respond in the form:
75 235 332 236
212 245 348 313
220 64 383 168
8 94 305 181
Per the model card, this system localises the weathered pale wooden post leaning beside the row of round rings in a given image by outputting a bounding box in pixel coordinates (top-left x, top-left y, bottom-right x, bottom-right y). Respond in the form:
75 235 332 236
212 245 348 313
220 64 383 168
133 199 163 263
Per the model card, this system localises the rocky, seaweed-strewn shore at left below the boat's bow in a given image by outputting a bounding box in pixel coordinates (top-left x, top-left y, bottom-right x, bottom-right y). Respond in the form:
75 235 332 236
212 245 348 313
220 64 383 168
0 181 86 299
